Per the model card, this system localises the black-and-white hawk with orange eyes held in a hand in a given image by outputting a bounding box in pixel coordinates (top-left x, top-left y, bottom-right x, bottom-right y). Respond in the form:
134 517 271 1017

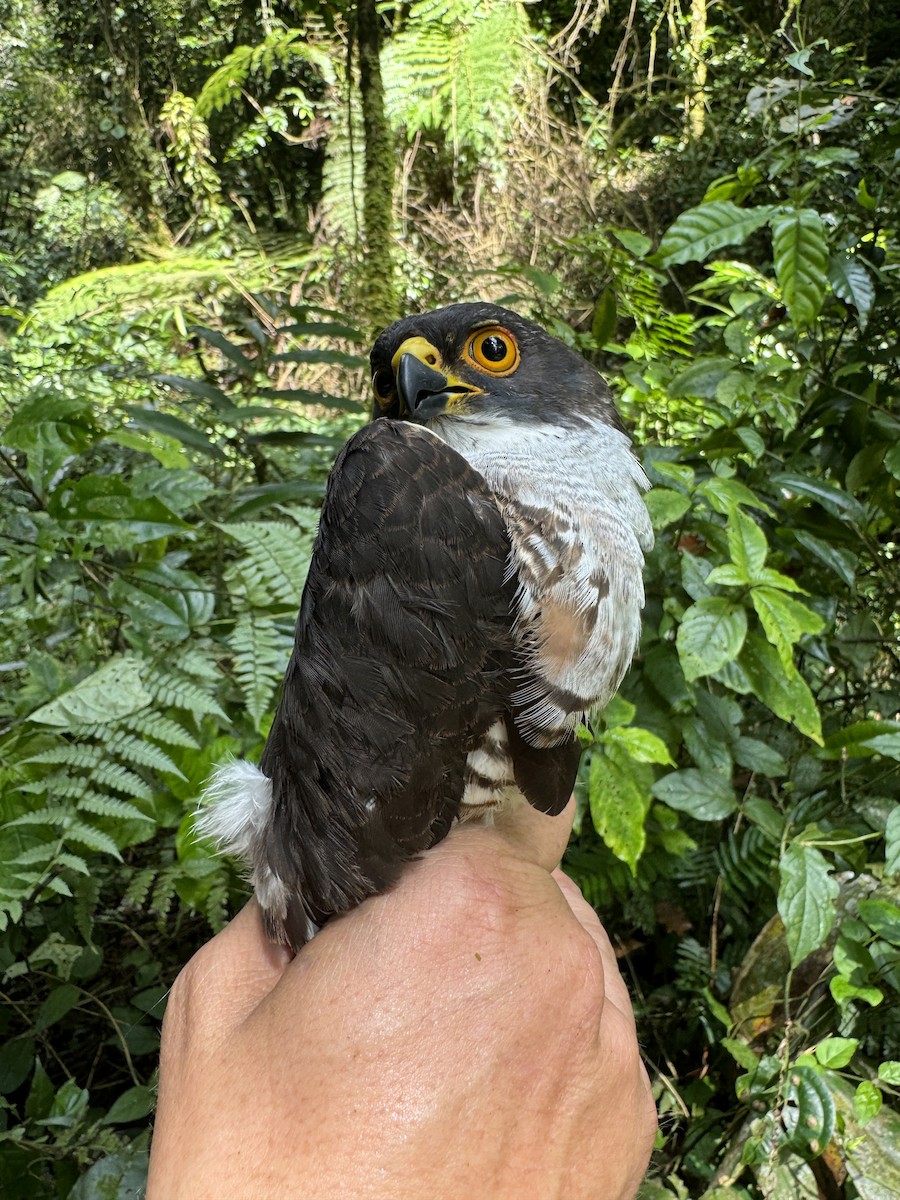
200 304 653 949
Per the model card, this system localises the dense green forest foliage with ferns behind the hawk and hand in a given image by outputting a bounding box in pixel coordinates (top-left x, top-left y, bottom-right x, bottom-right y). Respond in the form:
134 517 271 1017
0 0 900 1200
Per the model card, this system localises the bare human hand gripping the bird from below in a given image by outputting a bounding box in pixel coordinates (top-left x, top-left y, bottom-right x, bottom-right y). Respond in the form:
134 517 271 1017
148 805 656 1200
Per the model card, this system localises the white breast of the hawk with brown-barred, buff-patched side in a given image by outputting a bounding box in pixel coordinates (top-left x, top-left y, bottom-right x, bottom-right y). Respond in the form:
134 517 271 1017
436 418 653 745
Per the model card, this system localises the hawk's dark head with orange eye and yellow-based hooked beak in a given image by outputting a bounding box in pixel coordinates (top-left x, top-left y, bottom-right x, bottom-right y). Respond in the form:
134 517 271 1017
371 304 620 427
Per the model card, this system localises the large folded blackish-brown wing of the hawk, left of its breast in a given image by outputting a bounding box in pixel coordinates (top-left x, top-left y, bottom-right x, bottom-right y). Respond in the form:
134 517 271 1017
260 420 515 947
